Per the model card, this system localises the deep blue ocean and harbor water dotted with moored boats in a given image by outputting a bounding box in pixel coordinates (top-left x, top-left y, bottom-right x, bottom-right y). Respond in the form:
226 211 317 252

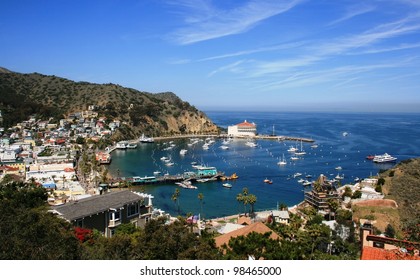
109 111 420 218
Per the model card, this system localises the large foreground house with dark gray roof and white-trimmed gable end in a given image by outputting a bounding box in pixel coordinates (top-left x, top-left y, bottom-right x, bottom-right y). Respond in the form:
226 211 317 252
51 190 153 237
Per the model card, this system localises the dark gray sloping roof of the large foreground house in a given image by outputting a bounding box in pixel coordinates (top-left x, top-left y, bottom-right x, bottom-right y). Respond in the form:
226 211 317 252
52 190 143 221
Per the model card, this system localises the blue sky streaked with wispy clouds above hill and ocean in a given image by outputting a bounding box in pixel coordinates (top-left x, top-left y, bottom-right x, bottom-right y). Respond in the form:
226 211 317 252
0 0 420 112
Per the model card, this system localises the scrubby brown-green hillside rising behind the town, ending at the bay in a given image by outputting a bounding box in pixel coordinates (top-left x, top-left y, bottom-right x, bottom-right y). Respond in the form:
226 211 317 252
0 68 218 136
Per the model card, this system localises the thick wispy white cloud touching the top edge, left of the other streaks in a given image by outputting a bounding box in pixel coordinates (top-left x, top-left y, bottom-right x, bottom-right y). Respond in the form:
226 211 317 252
171 0 303 45
